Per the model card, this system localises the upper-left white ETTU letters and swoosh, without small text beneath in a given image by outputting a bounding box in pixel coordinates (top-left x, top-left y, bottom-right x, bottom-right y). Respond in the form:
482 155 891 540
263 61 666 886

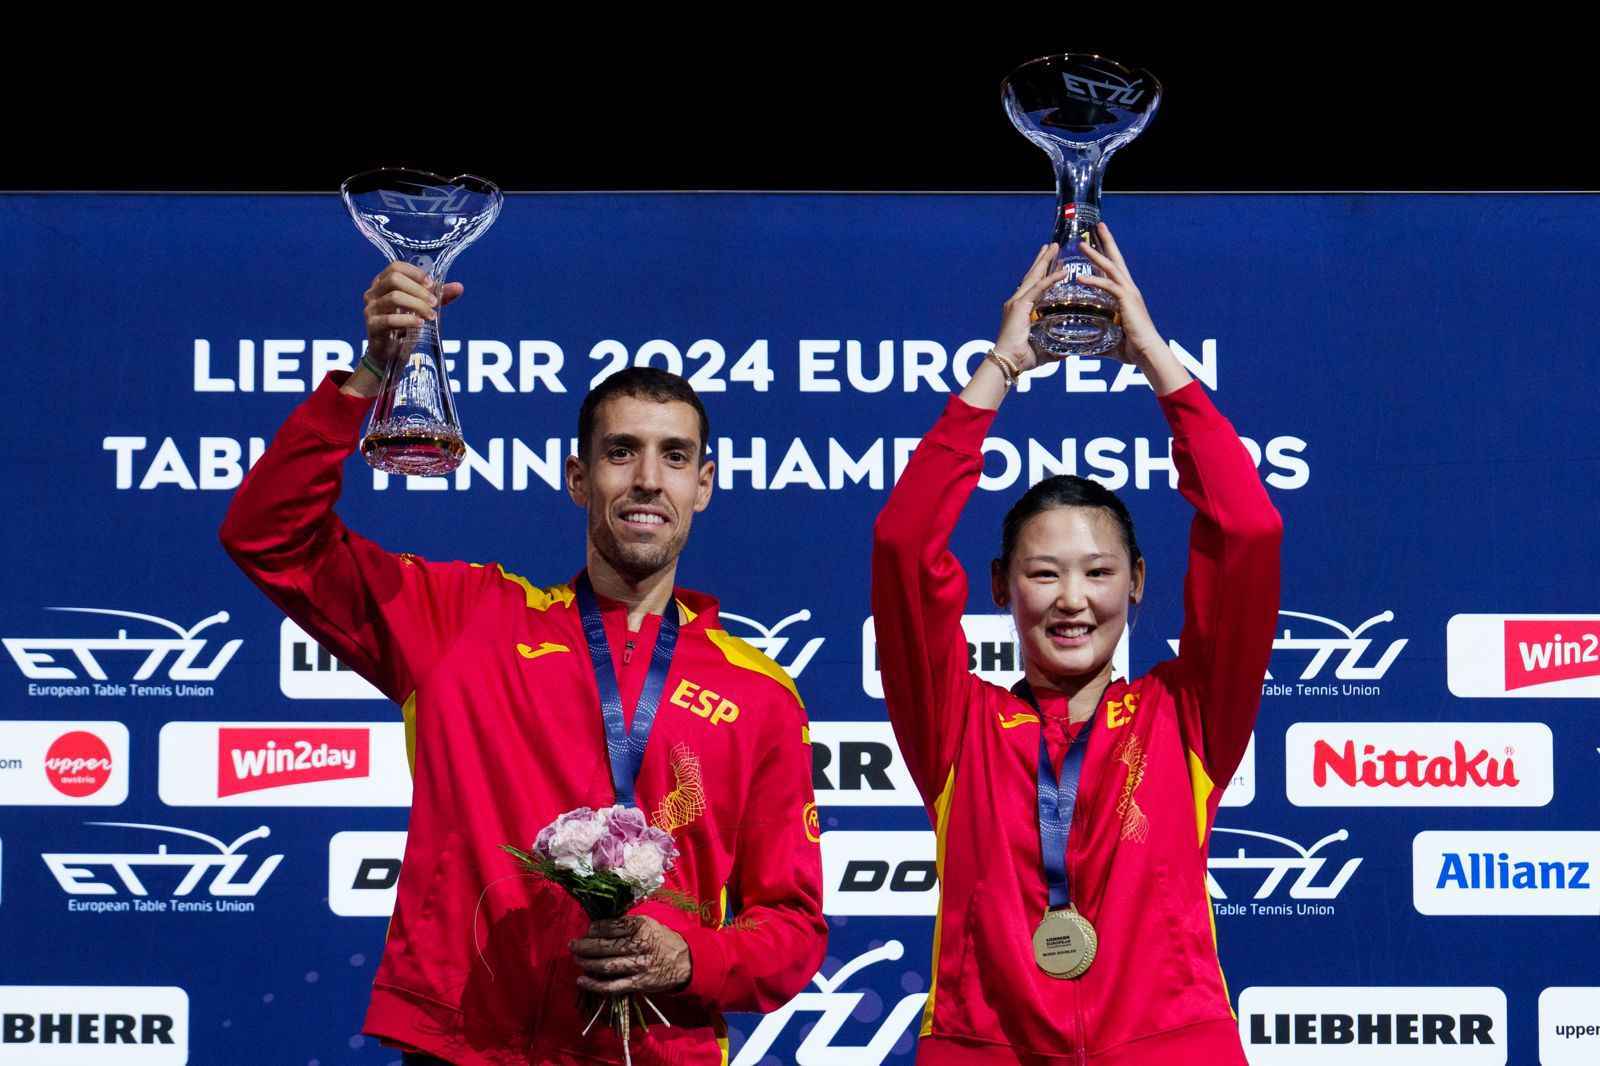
5 607 243 682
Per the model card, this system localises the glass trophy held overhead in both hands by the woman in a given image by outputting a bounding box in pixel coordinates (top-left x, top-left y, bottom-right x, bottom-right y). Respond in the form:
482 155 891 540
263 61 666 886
1002 54 1162 355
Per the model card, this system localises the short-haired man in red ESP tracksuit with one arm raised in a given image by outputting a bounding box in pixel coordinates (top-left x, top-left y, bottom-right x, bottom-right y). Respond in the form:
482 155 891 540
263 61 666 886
221 264 827 1066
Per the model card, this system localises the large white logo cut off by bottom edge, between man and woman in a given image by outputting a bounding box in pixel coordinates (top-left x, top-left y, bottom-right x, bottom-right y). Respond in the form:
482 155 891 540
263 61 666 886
733 940 928 1066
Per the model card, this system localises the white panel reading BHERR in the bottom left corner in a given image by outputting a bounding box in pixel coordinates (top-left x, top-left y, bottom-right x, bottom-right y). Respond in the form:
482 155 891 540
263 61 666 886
0 984 189 1066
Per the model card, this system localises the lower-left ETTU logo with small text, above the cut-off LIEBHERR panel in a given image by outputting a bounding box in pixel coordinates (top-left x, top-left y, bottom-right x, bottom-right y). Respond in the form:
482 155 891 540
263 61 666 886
40 821 283 912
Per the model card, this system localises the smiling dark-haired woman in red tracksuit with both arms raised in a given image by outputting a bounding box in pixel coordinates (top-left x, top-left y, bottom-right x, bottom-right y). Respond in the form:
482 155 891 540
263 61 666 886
872 226 1282 1066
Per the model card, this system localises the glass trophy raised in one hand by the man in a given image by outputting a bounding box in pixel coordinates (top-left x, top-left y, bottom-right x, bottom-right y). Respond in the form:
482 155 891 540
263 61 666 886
339 168 501 474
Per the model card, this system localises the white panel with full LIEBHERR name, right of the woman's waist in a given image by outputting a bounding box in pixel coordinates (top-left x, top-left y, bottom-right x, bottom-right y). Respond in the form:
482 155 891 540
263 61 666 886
1238 986 1507 1066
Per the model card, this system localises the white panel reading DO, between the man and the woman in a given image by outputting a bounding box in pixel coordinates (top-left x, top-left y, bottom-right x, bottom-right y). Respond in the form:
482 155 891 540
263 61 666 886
822 829 939 917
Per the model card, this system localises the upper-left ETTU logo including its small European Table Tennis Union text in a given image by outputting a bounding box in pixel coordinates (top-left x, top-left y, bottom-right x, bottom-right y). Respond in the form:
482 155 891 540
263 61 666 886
3 607 243 696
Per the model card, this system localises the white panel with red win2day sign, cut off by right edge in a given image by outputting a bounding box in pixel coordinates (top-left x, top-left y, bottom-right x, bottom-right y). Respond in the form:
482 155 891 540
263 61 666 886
1445 615 1600 699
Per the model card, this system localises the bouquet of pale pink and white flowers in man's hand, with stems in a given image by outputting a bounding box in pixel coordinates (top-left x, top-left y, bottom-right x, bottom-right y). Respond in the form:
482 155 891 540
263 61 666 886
501 807 678 1066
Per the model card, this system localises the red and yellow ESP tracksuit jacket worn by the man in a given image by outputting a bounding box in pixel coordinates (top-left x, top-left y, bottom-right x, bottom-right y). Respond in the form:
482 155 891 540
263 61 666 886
222 375 827 1066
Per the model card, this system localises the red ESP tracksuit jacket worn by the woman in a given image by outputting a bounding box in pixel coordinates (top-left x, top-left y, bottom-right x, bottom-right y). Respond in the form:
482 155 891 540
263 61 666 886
872 383 1282 1066
